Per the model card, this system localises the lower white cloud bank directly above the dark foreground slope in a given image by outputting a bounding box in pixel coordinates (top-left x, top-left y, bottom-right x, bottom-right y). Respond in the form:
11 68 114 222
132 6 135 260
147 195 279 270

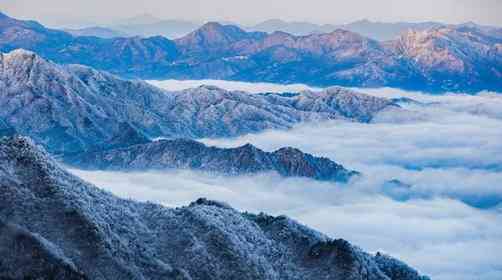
72 170 502 280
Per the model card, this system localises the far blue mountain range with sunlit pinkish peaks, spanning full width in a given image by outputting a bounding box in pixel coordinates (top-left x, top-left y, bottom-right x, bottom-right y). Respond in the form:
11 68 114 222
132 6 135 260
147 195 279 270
0 12 502 92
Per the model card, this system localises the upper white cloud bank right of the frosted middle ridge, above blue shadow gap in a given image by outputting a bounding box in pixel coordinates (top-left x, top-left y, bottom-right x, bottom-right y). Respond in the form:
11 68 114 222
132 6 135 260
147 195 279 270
196 89 502 207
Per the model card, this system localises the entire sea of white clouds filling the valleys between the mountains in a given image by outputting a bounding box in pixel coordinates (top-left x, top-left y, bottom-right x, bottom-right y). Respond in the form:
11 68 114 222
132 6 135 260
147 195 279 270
72 80 502 280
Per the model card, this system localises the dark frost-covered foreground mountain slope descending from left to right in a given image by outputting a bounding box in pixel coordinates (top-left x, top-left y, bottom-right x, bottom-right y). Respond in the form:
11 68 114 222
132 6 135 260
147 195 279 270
0 137 428 280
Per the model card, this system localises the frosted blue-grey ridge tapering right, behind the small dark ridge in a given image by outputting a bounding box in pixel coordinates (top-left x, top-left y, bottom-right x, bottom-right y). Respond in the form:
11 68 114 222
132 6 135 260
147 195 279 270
0 50 399 153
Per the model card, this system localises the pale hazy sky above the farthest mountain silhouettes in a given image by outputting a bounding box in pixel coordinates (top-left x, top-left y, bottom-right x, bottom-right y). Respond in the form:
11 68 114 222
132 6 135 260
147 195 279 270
0 0 502 25
